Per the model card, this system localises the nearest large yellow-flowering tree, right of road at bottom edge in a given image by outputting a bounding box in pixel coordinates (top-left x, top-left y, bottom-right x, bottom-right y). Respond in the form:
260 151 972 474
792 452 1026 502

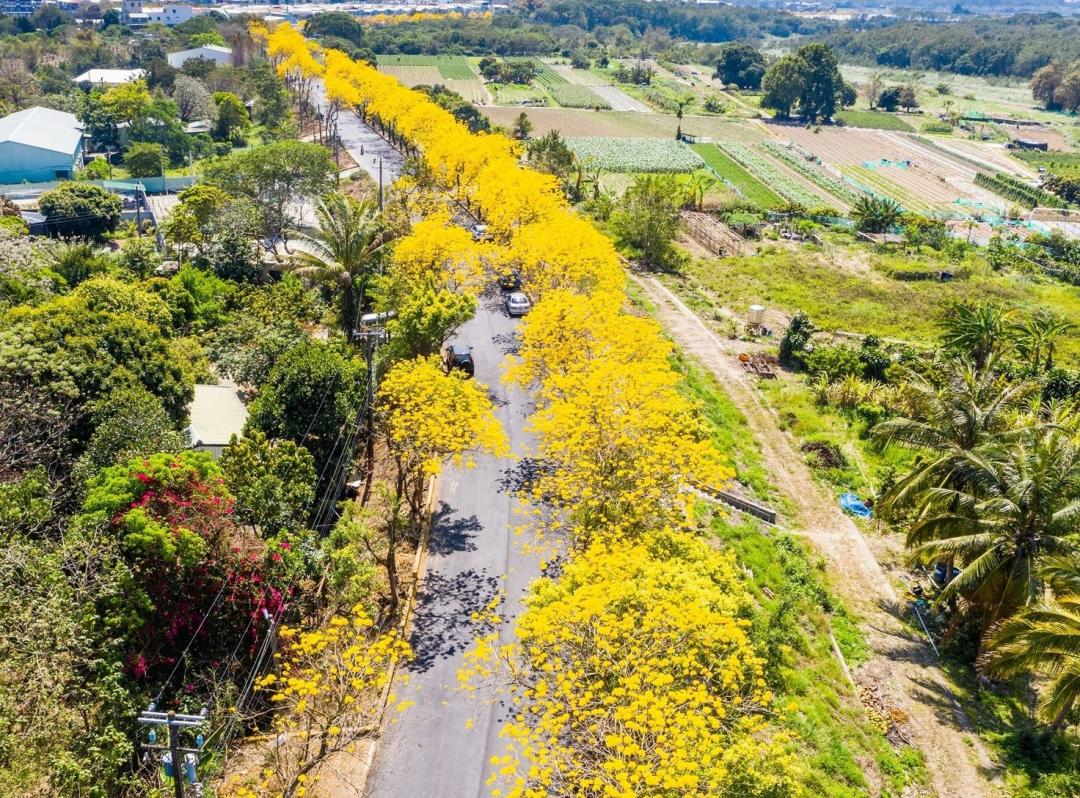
460 531 797 798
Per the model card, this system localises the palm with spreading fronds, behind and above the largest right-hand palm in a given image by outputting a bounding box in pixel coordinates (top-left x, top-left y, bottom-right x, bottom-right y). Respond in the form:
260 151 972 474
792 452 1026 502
872 357 1036 513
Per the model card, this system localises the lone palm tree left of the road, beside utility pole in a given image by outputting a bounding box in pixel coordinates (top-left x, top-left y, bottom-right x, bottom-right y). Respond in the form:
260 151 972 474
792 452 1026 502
289 193 393 340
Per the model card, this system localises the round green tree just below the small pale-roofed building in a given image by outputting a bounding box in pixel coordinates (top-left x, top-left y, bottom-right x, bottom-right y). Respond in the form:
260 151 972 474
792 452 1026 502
220 430 315 537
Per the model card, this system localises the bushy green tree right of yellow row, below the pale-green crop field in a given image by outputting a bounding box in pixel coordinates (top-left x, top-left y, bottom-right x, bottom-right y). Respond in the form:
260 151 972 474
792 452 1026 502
611 175 686 267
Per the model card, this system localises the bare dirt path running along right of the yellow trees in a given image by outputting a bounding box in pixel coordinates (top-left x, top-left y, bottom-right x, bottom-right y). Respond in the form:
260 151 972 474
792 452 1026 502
633 275 999 798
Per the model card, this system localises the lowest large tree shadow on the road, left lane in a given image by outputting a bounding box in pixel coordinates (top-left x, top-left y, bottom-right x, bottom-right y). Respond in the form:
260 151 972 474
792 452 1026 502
406 568 499 673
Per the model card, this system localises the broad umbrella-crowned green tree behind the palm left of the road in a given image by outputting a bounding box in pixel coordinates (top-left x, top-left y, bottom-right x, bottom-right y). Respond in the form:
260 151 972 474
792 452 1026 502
206 141 337 240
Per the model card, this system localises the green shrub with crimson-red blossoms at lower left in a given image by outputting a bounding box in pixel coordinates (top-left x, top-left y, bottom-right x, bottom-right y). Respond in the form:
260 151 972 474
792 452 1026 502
78 451 303 679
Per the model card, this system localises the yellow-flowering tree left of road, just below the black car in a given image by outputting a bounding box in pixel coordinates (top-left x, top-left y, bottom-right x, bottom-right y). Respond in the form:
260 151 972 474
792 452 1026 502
378 357 509 612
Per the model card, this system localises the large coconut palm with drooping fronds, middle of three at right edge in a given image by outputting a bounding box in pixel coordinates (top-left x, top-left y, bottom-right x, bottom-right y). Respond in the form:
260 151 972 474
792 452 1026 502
907 428 1080 627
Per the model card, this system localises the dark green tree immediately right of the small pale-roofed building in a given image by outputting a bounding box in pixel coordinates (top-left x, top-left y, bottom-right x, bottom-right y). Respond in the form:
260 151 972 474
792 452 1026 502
247 341 367 485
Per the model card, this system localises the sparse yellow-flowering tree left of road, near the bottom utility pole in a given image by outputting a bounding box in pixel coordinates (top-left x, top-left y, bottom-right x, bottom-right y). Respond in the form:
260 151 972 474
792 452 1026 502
244 605 410 798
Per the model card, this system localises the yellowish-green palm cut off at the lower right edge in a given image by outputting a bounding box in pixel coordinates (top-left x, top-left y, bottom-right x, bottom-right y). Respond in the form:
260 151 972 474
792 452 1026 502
982 557 1080 731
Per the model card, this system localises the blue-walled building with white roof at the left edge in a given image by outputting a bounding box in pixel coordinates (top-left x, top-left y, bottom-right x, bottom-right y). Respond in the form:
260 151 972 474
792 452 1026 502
0 106 83 184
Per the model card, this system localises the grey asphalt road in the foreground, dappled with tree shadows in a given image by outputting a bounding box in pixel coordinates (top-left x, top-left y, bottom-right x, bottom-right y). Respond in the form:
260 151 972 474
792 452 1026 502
367 290 539 798
